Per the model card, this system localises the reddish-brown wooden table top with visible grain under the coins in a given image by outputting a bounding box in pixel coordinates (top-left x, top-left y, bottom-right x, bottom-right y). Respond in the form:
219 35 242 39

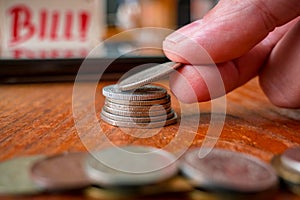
0 79 300 200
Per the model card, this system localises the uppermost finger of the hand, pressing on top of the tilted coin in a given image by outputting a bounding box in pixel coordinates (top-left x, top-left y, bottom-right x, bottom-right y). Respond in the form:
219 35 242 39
163 0 300 64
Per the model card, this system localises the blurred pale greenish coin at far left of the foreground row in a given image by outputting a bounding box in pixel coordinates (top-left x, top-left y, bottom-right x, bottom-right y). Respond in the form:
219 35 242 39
0 155 44 195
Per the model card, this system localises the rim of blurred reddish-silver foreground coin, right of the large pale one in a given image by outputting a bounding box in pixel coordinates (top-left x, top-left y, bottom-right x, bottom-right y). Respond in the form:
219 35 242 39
180 148 278 193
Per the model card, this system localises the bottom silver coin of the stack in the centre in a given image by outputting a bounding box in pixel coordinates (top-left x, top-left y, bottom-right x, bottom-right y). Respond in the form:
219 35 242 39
101 113 177 128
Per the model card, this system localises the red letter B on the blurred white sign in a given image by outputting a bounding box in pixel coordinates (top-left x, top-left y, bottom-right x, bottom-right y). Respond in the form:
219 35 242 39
9 5 35 45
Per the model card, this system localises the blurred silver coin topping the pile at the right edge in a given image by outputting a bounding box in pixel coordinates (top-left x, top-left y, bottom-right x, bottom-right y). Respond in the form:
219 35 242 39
281 147 300 173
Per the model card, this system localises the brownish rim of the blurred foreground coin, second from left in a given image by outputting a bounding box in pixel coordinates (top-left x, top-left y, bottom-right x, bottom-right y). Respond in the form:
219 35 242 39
30 152 91 190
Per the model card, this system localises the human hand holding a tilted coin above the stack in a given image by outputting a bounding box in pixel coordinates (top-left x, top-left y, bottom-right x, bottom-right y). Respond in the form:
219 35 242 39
163 0 300 108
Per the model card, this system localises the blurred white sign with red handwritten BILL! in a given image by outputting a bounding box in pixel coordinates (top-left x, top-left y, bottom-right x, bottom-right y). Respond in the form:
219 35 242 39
0 0 105 58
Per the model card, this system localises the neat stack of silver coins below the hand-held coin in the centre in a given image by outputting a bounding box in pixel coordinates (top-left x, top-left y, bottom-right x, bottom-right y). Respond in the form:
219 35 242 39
101 85 177 128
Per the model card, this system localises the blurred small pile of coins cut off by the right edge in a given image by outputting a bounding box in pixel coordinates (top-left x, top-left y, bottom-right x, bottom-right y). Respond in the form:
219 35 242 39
271 147 300 195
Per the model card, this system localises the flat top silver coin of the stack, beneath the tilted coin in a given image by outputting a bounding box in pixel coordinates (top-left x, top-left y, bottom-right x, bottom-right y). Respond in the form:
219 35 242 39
102 85 167 101
